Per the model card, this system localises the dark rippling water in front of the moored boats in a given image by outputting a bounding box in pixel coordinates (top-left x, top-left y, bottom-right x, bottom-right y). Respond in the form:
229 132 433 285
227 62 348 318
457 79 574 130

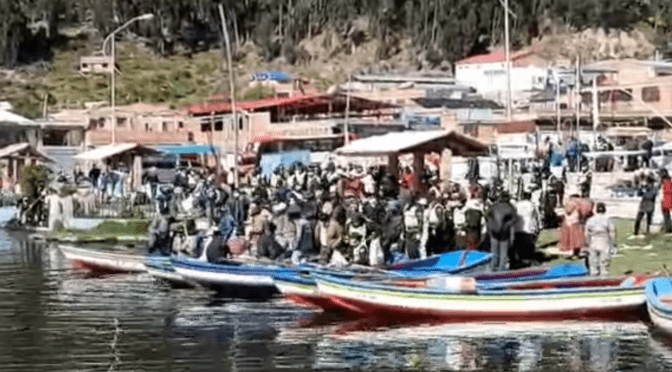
0 230 672 372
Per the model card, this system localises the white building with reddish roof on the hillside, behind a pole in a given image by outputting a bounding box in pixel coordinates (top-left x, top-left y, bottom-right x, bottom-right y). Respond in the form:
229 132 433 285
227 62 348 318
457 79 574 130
455 49 551 107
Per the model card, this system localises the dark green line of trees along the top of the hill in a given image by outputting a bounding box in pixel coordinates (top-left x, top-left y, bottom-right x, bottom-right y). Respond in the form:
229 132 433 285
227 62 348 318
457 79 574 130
0 0 672 67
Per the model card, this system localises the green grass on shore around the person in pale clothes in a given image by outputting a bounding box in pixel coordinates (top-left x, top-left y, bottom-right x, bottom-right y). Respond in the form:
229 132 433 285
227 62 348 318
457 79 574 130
537 220 672 275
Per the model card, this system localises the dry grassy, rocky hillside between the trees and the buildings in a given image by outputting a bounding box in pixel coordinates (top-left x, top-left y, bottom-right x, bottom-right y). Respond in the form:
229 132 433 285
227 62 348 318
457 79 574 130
0 24 655 118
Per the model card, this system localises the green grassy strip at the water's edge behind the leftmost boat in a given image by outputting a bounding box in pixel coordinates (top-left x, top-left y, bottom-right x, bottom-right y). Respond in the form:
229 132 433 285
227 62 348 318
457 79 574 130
50 220 149 242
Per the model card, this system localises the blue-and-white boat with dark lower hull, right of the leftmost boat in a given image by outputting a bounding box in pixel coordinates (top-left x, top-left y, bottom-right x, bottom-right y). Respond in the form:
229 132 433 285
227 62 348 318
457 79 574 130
172 257 292 298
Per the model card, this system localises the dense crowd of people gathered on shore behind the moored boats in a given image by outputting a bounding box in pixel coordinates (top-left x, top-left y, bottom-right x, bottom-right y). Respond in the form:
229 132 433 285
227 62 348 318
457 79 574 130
146 157 556 270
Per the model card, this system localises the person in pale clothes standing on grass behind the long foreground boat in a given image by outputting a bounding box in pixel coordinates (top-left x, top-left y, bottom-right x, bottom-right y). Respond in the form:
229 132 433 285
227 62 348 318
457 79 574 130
586 203 616 277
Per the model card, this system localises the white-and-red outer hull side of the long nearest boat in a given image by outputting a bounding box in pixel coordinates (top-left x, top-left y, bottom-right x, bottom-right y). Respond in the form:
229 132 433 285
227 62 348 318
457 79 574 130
317 277 645 321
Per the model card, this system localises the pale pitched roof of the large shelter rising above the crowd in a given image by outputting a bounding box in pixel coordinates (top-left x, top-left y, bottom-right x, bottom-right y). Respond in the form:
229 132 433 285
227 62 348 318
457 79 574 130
336 130 489 156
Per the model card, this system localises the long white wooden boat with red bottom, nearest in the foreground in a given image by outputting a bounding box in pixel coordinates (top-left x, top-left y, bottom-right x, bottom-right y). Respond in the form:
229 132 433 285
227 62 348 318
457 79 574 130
313 274 648 321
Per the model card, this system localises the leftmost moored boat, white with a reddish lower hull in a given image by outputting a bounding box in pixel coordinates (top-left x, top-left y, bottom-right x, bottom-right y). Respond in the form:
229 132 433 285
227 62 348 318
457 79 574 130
59 245 146 273
